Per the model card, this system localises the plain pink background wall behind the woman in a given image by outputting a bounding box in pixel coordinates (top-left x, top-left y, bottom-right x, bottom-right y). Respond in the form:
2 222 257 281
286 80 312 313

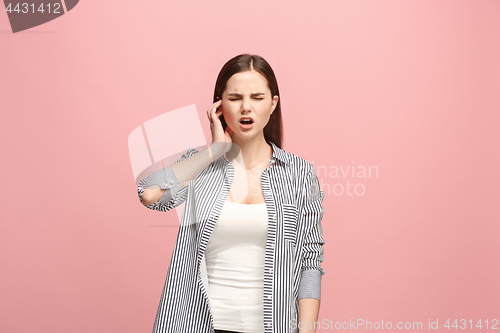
0 0 500 333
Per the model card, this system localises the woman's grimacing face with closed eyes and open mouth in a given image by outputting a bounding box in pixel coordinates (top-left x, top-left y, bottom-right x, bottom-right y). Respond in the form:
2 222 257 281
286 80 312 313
221 70 278 139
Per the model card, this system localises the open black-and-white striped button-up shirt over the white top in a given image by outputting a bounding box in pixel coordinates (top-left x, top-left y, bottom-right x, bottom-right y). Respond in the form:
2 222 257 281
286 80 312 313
138 143 325 333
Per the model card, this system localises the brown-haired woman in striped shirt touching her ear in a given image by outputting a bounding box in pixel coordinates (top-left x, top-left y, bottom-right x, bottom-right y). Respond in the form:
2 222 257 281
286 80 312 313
139 54 325 333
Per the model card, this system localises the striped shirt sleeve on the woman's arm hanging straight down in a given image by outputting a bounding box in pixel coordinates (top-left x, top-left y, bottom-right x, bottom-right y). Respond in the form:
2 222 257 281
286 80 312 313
298 167 325 300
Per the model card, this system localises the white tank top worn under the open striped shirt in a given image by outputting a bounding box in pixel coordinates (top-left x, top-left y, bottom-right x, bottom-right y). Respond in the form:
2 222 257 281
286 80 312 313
205 201 268 333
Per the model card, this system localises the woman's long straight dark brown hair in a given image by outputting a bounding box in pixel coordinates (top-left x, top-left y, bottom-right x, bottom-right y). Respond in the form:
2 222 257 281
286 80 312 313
214 54 283 148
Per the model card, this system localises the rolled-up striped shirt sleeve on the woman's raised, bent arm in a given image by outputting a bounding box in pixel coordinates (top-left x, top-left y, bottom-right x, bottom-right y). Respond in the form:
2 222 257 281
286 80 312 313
138 148 198 212
